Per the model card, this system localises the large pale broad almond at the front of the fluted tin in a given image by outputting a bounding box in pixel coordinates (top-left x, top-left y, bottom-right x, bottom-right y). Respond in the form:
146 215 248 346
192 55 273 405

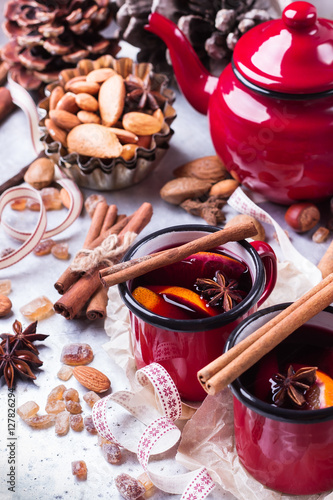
67 123 122 158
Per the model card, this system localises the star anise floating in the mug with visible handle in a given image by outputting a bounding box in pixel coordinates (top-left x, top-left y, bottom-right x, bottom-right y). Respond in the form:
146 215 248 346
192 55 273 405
195 271 246 312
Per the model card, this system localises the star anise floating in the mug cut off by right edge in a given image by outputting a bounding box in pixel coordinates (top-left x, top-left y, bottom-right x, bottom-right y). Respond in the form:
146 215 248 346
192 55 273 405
272 365 317 408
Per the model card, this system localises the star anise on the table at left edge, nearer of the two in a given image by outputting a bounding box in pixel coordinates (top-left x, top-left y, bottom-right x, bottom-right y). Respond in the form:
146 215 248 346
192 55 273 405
0 337 43 389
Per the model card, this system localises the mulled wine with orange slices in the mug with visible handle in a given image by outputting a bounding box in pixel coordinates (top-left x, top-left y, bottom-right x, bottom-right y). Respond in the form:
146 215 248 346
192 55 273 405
131 250 252 320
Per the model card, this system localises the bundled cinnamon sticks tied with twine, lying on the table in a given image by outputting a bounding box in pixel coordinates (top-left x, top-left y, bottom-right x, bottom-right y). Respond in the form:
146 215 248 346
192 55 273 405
54 202 153 319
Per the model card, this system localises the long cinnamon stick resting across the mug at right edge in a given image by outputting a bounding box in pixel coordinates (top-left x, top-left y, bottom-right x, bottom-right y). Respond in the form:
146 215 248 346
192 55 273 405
198 274 333 395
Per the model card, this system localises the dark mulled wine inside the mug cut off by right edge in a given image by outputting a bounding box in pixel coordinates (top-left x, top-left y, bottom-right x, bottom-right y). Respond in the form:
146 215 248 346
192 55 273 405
240 325 333 411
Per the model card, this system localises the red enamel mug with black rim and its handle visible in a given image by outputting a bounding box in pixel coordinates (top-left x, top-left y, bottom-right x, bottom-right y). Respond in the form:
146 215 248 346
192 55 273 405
119 225 276 401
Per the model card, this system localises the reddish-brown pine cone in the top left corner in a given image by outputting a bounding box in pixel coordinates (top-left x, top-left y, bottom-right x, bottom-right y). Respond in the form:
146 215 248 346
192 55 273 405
1 0 119 90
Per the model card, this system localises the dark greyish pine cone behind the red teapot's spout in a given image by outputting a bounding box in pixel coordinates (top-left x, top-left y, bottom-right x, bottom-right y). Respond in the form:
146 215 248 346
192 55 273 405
117 0 271 74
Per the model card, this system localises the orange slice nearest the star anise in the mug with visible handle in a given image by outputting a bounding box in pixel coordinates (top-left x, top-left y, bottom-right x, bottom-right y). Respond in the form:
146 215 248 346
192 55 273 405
149 286 219 316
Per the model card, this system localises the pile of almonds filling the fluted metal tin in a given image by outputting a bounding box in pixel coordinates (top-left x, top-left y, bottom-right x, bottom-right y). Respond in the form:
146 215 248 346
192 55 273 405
45 62 166 160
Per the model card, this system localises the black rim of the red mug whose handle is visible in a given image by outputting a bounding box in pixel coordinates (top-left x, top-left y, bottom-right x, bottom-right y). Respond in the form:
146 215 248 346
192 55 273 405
118 224 265 332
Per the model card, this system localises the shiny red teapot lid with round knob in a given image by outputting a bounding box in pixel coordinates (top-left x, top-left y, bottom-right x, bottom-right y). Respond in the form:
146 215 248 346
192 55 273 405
233 1 333 94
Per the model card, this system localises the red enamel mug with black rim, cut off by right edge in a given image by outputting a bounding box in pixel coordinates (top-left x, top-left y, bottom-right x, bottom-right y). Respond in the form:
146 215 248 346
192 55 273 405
226 304 333 495
